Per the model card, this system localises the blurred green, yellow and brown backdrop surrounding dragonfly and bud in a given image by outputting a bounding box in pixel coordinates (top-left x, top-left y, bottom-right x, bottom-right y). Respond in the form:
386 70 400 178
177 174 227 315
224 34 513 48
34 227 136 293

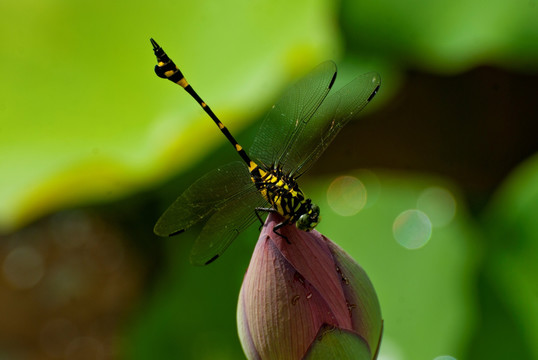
0 0 538 360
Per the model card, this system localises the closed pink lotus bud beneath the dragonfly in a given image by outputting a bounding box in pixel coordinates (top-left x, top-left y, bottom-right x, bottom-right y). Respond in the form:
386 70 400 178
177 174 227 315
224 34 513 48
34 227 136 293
237 213 383 360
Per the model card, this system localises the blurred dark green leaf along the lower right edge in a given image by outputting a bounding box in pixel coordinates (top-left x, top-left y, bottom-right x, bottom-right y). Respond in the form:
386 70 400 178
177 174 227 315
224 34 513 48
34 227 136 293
469 155 538 359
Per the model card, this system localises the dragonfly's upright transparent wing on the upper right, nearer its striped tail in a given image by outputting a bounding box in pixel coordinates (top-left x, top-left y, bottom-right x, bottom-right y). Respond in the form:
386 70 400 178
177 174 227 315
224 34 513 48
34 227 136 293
249 61 336 170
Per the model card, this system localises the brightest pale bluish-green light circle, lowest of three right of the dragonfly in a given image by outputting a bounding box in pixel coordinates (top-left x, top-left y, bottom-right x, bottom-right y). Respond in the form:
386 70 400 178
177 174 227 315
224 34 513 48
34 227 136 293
392 209 432 249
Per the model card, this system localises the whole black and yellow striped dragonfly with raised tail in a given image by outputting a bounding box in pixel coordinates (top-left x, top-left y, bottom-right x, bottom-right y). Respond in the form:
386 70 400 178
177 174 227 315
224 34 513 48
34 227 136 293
150 39 381 265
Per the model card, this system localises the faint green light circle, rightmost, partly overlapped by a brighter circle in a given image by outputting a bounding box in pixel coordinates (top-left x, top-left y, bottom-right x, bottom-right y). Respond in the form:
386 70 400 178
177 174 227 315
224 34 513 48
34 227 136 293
417 186 456 227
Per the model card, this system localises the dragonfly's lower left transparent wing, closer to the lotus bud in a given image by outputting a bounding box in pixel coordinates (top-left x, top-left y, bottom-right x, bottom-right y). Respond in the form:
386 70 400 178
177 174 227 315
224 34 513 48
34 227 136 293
190 186 268 265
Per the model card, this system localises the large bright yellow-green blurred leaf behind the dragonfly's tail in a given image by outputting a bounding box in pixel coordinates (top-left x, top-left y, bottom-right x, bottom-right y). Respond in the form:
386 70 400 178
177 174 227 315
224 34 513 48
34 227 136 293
0 0 339 231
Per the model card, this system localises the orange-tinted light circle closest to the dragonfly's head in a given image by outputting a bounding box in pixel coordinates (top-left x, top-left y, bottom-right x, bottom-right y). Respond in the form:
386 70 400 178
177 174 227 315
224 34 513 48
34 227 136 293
327 176 367 216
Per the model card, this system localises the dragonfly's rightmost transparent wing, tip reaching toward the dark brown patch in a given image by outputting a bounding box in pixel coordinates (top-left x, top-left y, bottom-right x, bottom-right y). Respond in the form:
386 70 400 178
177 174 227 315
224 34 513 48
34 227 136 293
281 73 381 178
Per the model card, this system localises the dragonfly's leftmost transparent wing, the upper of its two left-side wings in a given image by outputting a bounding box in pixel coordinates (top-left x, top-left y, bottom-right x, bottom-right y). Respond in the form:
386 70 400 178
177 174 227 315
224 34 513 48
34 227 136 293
154 161 257 236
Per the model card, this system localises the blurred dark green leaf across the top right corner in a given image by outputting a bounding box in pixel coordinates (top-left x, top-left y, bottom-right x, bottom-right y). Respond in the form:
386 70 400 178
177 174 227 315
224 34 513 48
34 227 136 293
342 0 538 73
